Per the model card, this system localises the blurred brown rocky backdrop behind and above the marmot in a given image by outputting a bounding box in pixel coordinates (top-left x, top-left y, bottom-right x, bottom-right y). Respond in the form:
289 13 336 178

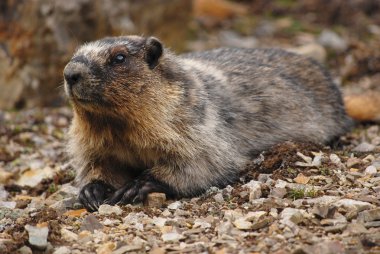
0 0 380 109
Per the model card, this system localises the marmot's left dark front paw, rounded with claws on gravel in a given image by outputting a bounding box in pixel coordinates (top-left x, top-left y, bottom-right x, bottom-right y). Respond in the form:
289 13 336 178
79 181 115 212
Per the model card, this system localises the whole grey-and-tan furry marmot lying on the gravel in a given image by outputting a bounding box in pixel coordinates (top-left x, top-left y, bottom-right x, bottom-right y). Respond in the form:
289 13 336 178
64 36 351 211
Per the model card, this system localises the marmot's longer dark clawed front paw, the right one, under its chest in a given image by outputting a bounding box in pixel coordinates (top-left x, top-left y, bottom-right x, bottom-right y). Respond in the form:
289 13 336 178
105 175 176 205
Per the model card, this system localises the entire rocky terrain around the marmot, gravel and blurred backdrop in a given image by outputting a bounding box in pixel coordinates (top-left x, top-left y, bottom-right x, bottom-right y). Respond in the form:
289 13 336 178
0 0 380 254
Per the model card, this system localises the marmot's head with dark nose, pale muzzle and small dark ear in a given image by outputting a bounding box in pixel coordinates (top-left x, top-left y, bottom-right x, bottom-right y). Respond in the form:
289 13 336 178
63 36 175 116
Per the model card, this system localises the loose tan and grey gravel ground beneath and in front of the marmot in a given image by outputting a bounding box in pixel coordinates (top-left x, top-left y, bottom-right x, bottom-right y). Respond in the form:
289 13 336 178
0 108 380 253
